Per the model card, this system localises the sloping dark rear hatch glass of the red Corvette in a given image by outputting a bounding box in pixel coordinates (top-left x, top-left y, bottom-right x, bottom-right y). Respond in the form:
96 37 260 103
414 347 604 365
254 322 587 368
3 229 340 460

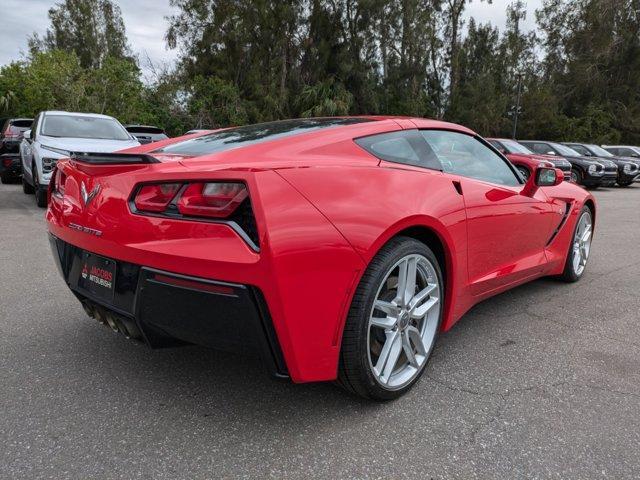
154 118 372 156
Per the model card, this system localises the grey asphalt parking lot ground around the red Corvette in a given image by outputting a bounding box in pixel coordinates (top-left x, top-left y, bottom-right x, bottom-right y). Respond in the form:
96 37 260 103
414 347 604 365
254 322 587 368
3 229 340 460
0 184 640 479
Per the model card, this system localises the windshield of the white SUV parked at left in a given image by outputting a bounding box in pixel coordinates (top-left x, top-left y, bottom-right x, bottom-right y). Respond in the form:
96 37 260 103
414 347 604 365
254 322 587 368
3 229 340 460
42 115 131 140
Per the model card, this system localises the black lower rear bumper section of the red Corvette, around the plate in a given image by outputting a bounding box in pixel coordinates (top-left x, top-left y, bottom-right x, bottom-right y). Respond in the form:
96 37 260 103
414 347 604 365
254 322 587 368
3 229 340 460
49 234 288 377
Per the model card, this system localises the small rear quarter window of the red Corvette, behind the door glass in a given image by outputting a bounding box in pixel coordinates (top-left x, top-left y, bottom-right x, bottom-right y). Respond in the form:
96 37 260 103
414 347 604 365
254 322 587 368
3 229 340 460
355 130 442 170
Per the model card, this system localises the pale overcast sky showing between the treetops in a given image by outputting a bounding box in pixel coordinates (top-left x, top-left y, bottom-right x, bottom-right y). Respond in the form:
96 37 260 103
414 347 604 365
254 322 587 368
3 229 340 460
0 0 541 74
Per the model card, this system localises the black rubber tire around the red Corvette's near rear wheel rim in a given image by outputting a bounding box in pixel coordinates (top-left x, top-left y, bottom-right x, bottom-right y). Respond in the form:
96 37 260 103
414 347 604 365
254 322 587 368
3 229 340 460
337 237 445 401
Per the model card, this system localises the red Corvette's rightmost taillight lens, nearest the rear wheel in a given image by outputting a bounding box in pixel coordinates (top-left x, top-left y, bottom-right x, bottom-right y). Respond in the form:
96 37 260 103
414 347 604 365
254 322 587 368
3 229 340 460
178 182 249 218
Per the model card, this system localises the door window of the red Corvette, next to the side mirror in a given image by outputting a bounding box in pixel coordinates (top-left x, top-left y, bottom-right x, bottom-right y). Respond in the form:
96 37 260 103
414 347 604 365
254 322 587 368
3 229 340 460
421 130 520 186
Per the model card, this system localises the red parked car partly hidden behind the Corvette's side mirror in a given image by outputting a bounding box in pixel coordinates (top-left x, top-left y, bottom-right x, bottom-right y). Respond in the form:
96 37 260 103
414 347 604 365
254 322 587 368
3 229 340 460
518 140 618 188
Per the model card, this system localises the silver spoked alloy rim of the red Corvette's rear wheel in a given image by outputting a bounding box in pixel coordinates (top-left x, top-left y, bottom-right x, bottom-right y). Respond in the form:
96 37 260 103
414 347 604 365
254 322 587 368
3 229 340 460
367 254 441 390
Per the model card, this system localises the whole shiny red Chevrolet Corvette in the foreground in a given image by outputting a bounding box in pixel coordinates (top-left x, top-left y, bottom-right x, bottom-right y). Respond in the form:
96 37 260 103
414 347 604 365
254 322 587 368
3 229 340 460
46 117 596 400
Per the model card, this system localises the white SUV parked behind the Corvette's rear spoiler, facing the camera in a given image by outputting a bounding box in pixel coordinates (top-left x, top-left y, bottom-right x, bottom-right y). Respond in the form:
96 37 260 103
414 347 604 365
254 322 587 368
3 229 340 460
20 111 140 207
